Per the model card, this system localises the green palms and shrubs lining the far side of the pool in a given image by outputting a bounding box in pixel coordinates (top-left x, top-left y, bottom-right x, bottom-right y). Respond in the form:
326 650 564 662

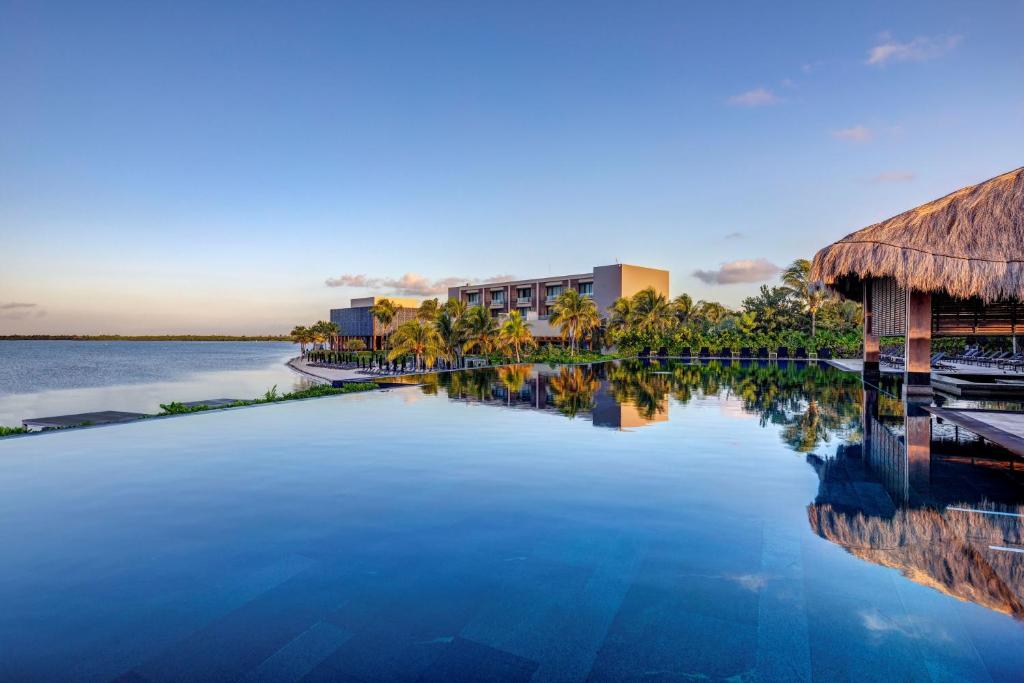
292 259 861 366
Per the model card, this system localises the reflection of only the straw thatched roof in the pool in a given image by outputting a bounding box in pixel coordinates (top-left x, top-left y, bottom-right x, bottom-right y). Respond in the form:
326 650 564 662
807 504 1024 620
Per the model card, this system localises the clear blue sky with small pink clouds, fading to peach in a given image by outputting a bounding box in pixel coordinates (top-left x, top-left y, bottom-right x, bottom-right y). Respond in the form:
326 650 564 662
0 0 1024 334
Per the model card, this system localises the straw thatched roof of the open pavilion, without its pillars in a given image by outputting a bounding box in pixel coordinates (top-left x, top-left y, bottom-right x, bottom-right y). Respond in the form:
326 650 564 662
811 167 1024 302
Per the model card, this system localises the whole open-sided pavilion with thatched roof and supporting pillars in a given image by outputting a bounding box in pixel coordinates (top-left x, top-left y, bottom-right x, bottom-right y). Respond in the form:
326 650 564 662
811 168 1024 393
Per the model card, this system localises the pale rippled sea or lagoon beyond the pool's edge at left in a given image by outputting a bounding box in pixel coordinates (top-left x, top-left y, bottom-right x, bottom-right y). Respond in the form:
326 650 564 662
0 341 307 426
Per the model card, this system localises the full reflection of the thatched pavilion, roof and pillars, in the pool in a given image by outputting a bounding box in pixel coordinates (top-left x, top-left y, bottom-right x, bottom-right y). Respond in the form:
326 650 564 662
807 386 1024 620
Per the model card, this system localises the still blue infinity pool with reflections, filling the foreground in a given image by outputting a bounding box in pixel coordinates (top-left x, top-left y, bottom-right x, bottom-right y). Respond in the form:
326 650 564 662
0 364 1024 682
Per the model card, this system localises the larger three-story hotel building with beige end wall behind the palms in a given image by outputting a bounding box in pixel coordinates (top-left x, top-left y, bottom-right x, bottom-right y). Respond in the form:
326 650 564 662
449 263 669 339
